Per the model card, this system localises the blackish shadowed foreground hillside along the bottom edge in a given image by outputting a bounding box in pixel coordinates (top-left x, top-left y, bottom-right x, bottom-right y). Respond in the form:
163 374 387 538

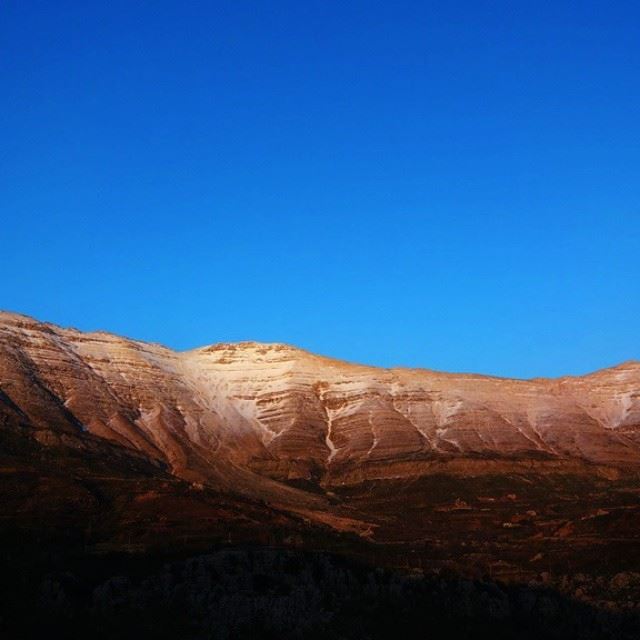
0 548 640 640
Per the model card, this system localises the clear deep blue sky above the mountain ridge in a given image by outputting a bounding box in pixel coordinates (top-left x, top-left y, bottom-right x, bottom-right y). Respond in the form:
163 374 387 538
0 0 640 377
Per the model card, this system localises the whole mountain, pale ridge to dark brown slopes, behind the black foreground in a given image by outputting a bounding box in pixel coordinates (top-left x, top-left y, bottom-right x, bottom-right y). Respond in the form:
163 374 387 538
0 313 640 592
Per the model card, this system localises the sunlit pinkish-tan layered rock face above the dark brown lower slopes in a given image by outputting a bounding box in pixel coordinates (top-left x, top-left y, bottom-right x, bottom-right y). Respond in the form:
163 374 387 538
0 313 640 484
